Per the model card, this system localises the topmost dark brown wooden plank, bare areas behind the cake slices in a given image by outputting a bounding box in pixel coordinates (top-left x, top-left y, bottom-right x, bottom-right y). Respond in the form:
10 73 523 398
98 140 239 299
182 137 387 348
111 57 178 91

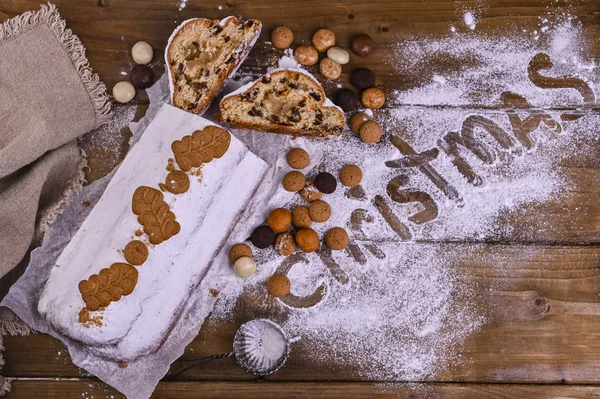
0 0 600 106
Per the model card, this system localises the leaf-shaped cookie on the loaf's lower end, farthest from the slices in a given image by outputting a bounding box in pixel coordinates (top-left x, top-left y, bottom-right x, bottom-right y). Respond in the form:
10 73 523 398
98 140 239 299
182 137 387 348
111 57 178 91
79 263 138 311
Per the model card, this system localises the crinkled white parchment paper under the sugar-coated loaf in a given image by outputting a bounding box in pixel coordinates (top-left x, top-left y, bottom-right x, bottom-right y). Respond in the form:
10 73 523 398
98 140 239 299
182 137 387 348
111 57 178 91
0 75 321 399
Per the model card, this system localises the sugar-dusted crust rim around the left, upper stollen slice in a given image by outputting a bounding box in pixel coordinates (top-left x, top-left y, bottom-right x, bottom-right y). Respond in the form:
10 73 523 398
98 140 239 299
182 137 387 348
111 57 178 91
165 16 262 114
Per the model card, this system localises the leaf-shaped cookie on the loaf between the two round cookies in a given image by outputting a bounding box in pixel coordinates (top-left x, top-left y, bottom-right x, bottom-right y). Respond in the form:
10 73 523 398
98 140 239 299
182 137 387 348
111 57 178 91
132 186 181 245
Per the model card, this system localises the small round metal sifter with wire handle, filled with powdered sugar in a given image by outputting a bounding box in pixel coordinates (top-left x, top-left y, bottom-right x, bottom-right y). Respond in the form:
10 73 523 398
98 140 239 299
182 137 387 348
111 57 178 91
171 319 299 378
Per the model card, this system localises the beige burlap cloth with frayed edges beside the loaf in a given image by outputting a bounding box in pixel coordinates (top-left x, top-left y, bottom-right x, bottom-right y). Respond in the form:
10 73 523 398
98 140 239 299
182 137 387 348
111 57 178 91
0 4 111 391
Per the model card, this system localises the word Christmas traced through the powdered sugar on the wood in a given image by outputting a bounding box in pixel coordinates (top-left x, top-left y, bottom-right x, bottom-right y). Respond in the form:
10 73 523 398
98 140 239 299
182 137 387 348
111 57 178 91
276 53 596 308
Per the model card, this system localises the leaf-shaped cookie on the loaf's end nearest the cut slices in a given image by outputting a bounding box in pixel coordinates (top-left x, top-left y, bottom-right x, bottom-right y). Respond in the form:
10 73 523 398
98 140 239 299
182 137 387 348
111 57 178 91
171 126 231 172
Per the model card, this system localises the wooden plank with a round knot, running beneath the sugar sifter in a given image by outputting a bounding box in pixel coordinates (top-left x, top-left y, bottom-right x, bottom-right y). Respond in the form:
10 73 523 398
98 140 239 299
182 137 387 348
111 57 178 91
3 244 600 383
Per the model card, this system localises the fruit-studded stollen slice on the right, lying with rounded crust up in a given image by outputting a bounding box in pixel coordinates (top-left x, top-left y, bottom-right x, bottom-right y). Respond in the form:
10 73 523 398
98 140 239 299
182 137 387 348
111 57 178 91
219 70 345 136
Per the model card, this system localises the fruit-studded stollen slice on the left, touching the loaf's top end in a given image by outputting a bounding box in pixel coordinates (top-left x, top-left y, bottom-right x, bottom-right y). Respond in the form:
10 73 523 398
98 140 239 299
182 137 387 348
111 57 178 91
165 17 262 114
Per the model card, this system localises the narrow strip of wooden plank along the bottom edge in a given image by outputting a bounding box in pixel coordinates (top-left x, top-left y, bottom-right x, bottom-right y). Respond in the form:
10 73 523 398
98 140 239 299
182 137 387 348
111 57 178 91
8 380 600 399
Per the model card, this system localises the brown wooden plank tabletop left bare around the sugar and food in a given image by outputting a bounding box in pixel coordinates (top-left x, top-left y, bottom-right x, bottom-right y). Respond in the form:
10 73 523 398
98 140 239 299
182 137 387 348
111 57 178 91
0 0 600 398
